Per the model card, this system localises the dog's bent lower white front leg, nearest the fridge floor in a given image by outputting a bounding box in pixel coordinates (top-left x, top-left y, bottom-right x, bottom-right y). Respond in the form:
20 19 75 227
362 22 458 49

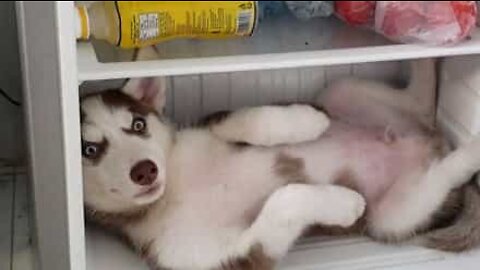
232 184 365 260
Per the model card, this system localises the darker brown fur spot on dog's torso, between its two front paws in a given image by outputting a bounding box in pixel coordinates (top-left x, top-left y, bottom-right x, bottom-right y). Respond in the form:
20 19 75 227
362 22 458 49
274 153 308 183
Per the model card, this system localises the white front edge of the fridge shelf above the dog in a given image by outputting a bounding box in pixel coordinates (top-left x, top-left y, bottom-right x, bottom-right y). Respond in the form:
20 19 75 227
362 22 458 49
77 31 480 81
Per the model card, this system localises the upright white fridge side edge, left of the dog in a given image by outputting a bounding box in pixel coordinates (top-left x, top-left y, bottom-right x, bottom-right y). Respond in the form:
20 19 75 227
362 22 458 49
17 1 86 270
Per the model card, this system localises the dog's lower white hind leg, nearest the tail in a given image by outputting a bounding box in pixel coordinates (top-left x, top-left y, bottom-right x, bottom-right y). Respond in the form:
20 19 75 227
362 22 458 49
367 136 480 240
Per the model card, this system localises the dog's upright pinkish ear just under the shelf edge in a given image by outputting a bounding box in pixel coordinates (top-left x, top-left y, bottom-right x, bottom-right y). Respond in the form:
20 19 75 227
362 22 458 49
122 77 166 112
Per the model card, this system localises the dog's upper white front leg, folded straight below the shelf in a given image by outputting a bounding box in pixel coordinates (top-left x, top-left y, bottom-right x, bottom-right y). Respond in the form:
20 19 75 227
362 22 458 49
207 104 330 146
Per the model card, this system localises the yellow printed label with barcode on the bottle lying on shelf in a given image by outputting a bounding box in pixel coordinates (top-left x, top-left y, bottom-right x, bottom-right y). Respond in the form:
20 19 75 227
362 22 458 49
115 1 257 48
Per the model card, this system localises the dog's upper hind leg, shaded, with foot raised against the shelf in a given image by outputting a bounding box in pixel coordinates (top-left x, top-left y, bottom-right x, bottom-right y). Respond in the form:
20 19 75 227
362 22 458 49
317 59 436 129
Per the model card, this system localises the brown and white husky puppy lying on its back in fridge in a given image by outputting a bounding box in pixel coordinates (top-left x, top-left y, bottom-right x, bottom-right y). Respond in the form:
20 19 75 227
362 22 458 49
81 49 480 269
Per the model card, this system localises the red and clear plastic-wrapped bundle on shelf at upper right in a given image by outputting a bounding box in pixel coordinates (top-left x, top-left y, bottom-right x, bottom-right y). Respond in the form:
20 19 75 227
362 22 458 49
335 1 477 45
